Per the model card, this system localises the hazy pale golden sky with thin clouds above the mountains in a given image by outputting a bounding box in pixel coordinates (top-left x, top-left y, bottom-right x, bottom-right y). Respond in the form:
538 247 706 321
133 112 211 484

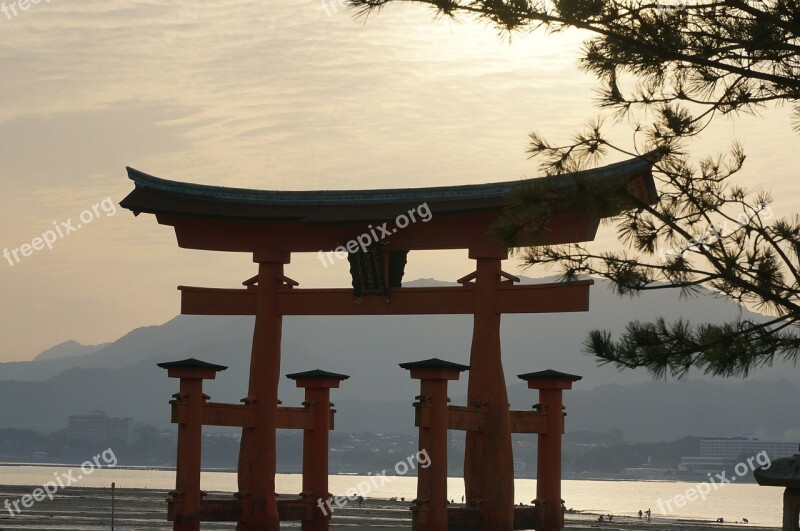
0 0 800 360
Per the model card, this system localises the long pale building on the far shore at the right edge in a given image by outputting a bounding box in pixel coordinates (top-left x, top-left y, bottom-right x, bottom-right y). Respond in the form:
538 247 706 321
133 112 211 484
679 437 798 473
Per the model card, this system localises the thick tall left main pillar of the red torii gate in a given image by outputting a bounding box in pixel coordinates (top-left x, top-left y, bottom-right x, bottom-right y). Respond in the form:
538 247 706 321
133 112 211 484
236 251 290 531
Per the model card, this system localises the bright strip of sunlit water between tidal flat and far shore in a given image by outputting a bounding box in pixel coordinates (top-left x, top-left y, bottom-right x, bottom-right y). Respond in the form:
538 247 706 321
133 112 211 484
0 465 783 527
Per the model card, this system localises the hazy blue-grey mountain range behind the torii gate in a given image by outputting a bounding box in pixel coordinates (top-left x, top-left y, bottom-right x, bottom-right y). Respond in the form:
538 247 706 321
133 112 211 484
0 279 800 442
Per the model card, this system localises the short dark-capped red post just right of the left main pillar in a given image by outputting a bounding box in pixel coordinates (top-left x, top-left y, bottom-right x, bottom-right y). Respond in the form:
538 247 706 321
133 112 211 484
286 369 349 531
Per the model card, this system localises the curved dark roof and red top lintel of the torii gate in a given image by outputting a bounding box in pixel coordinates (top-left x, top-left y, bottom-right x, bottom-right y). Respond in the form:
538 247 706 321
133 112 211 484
120 157 656 252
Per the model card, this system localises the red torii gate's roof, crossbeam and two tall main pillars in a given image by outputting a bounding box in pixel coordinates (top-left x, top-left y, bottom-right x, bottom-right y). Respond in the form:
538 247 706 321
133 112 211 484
121 159 656 531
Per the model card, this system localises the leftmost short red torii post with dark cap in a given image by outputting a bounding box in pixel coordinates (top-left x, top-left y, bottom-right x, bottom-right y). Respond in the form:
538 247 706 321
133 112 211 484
158 358 227 531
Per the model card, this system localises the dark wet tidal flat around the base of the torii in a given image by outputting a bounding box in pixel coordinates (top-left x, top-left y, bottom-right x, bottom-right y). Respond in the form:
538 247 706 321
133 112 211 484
0 485 780 531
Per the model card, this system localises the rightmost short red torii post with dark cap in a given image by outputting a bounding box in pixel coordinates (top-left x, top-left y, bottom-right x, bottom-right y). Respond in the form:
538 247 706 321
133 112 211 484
519 370 583 531
